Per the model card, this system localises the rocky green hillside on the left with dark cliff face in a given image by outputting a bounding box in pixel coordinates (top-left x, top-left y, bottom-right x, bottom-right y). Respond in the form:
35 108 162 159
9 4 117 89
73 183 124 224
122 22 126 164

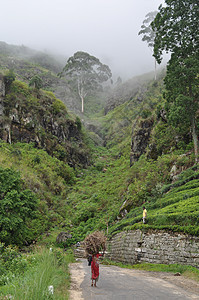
0 59 91 247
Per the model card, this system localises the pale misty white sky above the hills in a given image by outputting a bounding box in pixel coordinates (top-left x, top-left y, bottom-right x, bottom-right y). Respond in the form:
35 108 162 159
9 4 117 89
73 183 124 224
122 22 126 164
0 0 164 79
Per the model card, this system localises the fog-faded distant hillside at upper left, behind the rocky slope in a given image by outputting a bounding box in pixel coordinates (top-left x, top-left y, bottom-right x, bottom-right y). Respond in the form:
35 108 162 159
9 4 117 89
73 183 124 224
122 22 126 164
0 42 81 113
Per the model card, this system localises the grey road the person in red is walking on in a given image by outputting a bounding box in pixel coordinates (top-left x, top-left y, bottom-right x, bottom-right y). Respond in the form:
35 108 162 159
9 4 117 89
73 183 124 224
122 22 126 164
70 259 199 300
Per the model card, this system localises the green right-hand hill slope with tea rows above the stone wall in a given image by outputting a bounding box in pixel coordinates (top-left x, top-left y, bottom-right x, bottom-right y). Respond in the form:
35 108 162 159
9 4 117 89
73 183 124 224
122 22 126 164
56 71 199 242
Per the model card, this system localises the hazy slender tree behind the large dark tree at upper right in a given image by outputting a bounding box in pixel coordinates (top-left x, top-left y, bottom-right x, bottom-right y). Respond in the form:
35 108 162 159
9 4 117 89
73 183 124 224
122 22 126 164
138 11 157 80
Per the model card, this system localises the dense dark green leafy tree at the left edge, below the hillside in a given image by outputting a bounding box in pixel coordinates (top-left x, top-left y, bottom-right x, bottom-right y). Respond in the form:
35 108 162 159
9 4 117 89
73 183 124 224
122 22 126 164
0 167 38 245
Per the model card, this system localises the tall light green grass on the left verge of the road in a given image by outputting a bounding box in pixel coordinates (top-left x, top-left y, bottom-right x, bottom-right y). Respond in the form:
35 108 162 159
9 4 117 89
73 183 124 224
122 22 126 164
0 248 74 300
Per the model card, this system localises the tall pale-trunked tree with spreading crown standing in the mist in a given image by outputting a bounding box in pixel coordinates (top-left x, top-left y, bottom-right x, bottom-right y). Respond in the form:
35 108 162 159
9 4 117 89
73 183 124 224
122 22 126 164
59 51 112 113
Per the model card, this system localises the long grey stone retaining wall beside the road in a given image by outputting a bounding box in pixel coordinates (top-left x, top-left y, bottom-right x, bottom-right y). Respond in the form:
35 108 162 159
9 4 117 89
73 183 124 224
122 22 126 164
106 230 199 268
